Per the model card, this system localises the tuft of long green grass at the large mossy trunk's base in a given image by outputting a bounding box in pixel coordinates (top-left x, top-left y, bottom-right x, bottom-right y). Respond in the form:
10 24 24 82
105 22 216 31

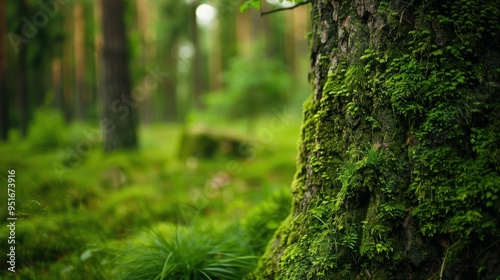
111 222 256 280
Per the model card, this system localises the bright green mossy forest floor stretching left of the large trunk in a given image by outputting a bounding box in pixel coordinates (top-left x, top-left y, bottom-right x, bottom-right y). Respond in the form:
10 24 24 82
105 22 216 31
0 112 300 280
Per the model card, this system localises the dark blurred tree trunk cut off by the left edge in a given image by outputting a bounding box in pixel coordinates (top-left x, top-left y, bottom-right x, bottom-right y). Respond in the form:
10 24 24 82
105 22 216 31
0 0 9 141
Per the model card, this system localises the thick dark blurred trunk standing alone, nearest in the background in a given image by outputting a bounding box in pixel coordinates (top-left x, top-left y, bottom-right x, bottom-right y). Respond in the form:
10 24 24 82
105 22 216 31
100 0 137 152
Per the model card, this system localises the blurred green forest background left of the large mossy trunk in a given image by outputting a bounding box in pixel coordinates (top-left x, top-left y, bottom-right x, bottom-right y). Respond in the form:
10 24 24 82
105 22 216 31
0 0 310 279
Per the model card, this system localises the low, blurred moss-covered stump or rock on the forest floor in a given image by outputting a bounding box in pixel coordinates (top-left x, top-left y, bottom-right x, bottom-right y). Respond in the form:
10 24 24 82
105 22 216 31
179 126 249 159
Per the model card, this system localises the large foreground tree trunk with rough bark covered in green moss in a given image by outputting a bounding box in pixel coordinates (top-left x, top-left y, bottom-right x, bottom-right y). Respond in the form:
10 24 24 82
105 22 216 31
252 0 500 279
